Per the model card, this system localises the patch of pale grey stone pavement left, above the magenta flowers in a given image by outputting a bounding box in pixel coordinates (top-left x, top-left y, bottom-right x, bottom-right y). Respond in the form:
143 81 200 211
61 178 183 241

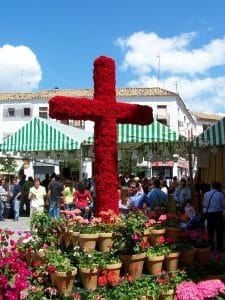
0 217 30 240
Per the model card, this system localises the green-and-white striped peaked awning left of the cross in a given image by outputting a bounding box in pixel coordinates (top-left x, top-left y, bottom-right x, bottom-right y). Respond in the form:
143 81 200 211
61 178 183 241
0 117 91 152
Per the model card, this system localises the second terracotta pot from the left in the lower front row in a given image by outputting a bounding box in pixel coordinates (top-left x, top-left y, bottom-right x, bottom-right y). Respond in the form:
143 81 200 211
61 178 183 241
79 268 99 290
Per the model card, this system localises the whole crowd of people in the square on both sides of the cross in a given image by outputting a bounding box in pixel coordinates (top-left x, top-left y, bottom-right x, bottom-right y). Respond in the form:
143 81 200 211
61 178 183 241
0 174 225 251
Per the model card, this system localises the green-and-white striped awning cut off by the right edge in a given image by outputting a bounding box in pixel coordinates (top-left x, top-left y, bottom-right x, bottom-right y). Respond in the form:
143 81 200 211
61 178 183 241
192 117 225 148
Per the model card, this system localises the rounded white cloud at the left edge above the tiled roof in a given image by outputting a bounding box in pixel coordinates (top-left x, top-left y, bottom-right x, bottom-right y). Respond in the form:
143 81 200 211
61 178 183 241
0 45 42 92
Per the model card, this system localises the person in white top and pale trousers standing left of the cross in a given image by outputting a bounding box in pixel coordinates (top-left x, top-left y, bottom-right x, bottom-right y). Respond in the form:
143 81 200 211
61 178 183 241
28 178 46 216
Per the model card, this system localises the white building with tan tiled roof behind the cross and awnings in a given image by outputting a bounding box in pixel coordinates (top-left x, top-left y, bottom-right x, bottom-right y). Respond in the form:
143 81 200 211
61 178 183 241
0 87 221 177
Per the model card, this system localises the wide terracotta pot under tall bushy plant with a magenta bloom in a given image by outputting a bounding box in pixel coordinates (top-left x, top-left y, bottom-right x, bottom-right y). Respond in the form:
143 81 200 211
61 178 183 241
120 253 145 279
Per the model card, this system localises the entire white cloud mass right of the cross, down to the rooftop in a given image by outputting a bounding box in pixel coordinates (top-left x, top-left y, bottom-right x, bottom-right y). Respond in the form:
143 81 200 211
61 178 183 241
117 32 225 113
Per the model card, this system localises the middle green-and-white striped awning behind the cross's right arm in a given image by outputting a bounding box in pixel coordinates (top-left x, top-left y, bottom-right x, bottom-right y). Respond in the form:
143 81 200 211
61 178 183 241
84 121 184 144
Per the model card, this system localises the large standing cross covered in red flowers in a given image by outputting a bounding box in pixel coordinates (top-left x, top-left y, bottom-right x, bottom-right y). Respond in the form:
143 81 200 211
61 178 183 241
49 56 153 216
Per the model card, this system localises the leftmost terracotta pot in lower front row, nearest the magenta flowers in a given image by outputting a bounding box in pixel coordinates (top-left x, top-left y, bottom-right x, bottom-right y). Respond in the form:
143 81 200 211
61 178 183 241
53 268 77 296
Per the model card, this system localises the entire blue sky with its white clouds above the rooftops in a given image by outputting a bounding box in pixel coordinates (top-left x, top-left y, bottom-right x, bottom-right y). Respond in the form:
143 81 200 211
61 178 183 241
0 0 225 114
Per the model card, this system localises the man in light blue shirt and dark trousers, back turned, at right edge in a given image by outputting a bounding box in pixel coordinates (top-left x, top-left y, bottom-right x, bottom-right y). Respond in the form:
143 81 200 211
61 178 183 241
203 182 225 251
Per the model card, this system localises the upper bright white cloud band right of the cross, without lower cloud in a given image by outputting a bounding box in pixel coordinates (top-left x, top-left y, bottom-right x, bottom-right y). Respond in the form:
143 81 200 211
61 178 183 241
117 32 225 76
